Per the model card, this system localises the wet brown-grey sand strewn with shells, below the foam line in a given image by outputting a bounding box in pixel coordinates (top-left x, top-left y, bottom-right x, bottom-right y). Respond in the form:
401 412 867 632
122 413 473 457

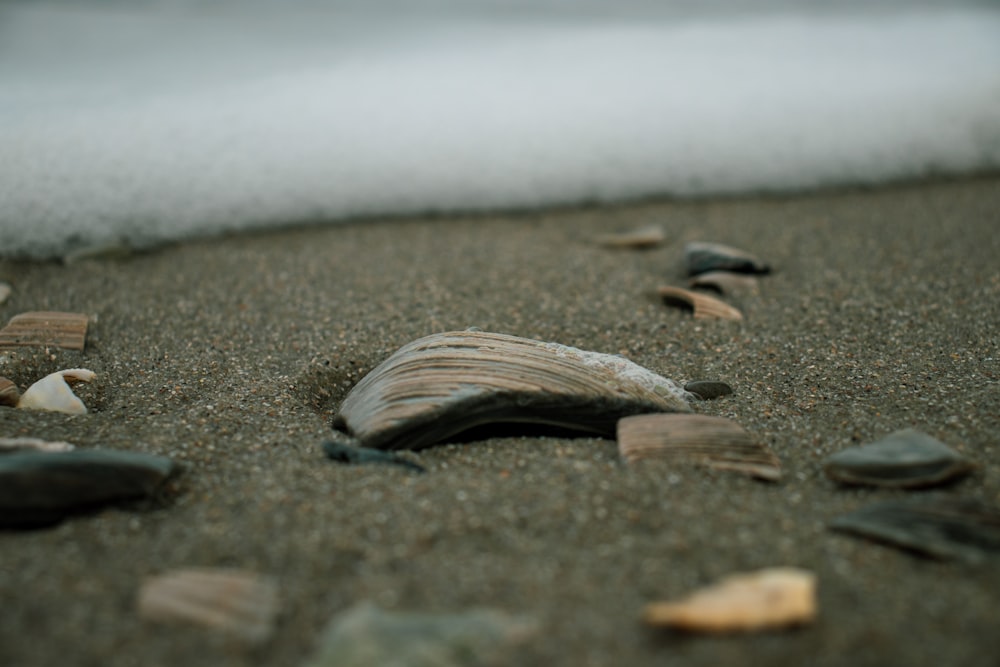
0 176 1000 667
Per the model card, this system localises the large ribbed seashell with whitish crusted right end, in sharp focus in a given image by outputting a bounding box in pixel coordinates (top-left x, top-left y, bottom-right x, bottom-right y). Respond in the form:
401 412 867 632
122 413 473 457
334 331 691 449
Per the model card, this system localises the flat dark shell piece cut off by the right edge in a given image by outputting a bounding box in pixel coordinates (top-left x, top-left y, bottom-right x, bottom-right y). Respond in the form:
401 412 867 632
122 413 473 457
830 496 1000 563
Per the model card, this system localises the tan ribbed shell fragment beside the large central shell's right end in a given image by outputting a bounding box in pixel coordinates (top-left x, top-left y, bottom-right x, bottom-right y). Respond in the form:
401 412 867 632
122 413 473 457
618 414 781 482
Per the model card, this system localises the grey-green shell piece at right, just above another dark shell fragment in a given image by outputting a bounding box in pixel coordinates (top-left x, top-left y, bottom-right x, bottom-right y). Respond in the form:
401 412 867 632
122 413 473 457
824 429 975 488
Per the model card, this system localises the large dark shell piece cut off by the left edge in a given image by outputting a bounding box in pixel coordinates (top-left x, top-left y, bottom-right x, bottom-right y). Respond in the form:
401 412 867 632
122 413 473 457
0 449 177 527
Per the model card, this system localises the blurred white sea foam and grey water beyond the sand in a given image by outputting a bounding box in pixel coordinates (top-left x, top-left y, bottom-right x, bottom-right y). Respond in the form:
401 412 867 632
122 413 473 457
0 0 1000 257
